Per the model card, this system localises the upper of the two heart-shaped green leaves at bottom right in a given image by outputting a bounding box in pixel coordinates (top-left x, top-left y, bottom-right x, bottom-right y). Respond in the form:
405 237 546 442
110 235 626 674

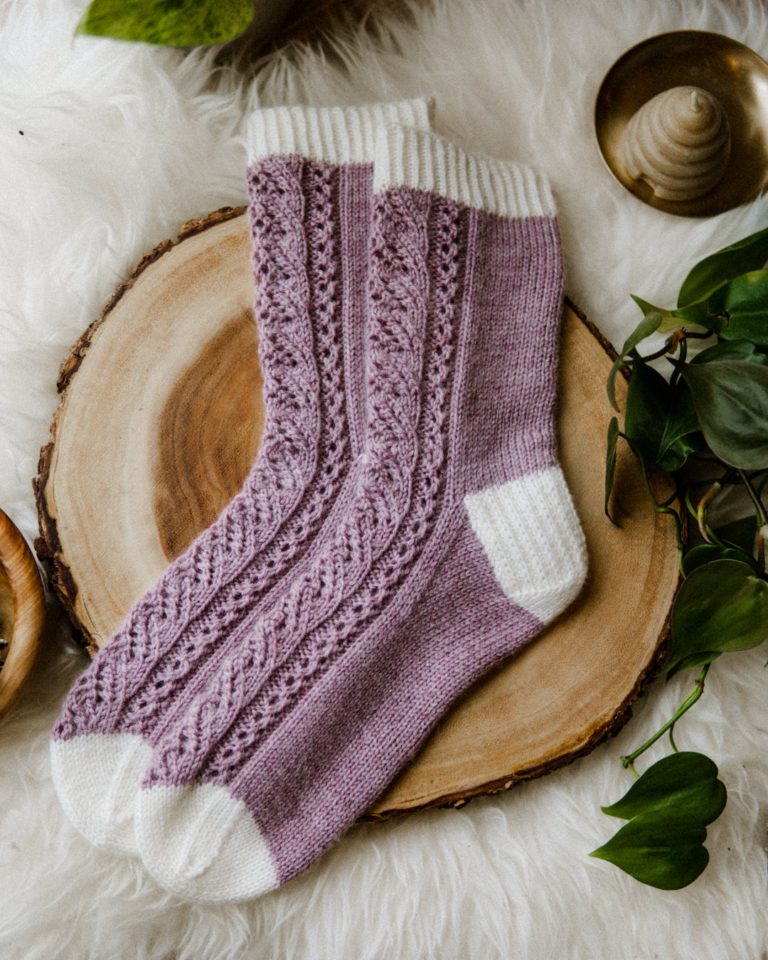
600 750 727 825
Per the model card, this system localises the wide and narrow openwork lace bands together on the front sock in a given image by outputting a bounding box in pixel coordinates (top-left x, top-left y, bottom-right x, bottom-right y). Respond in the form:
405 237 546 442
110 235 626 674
145 191 450 785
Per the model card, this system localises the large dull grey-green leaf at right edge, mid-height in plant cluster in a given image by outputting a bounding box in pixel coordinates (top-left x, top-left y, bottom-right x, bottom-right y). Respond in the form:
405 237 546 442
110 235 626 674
682 360 768 470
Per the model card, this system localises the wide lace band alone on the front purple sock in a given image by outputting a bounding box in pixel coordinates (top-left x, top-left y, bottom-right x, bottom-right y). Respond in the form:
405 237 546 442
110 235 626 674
146 192 429 783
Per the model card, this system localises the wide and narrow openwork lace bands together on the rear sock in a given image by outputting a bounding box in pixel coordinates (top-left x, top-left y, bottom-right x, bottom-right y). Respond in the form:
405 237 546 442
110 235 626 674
54 157 349 738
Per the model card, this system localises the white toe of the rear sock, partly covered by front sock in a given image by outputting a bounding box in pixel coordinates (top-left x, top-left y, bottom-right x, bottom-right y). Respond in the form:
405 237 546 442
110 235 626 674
51 733 152 854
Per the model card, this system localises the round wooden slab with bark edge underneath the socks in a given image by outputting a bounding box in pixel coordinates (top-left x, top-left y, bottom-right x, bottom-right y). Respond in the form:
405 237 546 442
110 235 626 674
35 209 677 817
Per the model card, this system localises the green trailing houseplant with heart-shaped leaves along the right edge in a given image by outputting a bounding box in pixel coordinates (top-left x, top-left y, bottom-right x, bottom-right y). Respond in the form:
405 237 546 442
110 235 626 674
590 223 768 889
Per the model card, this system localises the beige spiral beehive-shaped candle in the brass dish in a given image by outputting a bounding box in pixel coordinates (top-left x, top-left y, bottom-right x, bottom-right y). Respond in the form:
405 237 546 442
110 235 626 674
624 86 731 201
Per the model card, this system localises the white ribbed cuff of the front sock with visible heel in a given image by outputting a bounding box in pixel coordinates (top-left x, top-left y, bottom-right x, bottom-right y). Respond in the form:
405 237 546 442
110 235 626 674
373 124 556 217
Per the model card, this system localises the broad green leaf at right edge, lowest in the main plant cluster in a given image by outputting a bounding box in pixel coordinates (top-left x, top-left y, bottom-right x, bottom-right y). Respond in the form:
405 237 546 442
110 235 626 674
667 560 768 672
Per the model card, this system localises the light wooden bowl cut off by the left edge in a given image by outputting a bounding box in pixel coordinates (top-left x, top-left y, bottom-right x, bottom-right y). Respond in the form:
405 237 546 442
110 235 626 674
0 510 45 715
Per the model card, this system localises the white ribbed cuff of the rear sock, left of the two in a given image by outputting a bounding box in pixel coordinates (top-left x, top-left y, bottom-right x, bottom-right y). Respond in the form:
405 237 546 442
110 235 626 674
245 98 434 163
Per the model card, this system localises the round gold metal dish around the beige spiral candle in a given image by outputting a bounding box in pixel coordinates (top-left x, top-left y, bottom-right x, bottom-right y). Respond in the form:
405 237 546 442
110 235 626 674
595 30 768 217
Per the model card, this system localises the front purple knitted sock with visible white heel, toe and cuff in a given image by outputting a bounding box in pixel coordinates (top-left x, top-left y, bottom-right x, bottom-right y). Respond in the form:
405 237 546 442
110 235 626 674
136 126 586 901
